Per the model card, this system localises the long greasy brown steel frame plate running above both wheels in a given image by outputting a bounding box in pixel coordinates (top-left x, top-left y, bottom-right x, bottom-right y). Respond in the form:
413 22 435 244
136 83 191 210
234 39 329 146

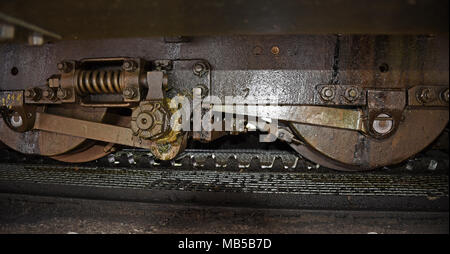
0 35 449 104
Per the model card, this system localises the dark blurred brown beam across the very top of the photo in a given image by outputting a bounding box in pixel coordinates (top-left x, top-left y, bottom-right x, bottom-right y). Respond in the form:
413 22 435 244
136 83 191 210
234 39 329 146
0 0 448 39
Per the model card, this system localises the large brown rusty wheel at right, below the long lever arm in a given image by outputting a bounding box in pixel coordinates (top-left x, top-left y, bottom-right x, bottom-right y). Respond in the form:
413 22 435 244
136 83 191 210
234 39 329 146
294 109 448 170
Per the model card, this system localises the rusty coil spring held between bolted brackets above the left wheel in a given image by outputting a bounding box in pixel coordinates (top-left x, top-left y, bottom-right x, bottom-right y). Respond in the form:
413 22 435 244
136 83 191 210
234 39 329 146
75 70 123 95
